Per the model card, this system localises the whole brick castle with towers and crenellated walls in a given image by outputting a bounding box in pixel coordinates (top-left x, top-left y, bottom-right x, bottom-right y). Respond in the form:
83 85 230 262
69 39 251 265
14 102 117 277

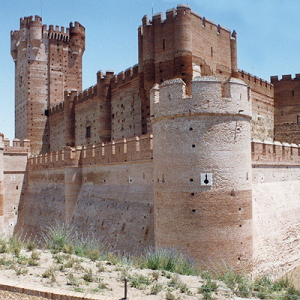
0 5 300 273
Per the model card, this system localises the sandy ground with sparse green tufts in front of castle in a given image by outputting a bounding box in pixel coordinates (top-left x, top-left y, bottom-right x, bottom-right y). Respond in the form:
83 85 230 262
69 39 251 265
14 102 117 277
0 250 233 300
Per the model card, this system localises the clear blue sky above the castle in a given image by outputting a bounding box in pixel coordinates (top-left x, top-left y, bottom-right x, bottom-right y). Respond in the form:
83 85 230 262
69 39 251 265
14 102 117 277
0 0 300 140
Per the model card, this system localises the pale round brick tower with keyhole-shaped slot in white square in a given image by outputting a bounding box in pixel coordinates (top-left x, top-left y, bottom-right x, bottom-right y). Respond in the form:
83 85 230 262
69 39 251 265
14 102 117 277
151 77 252 268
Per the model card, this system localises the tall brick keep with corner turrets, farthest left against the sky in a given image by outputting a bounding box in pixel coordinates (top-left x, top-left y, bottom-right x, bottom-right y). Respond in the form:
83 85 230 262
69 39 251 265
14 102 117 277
11 16 85 153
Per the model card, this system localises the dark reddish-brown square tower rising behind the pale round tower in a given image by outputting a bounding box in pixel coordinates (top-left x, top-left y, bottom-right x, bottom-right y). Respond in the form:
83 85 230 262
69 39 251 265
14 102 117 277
138 4 238 134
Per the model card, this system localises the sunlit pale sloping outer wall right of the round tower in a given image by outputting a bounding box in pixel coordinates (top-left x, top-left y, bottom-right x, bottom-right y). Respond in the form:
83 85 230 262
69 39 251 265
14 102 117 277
252 141 300 276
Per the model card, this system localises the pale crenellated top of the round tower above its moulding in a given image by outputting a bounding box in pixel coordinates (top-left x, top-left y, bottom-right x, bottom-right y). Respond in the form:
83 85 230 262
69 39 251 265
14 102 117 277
150 76 252 118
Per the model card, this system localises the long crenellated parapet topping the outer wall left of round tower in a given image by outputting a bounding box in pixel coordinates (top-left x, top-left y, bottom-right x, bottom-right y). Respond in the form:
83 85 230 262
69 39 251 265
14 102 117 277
28 134 153 170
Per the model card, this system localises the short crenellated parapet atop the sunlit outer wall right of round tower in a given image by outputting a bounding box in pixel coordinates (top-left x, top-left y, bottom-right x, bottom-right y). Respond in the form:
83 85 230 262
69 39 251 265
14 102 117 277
251 140 300 165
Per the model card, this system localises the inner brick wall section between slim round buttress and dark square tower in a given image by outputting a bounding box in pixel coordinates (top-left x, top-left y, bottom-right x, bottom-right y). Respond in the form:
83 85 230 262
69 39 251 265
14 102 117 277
111 66 142 140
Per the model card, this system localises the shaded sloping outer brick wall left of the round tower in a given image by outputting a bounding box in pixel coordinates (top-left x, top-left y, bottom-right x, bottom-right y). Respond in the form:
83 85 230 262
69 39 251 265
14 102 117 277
16 135 154 252
